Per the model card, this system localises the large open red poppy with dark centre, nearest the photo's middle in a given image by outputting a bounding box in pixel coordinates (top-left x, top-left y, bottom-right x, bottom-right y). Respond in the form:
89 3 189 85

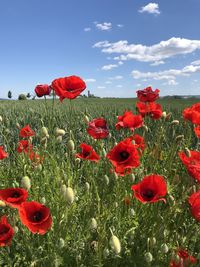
107 137 140 176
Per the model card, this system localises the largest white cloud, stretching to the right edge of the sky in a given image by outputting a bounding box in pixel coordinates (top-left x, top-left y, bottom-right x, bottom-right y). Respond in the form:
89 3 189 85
93 37 200 62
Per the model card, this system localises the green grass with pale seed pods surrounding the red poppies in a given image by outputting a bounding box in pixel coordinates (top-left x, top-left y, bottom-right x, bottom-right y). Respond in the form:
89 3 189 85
0 98 200 267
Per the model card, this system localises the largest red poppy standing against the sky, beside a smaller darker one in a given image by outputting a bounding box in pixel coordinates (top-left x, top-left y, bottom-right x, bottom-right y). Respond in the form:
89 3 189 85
51 76 86 101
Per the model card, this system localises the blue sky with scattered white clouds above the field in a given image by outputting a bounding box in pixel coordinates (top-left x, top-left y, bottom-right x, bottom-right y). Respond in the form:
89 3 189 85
0 0 200 97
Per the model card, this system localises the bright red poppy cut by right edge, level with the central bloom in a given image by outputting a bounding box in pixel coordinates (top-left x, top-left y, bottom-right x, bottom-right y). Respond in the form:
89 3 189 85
179 150 200 183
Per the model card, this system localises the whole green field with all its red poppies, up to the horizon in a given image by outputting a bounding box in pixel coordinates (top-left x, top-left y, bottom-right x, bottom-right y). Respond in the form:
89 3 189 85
0 76 200 267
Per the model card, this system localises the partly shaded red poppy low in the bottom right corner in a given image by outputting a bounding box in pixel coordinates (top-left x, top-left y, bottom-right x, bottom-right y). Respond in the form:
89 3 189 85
169 249 197 267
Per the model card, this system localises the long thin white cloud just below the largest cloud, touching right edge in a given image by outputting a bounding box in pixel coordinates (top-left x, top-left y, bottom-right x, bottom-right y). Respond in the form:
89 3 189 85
132 64 200 81
